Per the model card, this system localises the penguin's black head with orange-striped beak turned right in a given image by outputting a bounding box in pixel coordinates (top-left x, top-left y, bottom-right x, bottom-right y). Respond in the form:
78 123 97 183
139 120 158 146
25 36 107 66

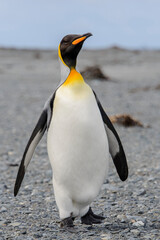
58 33 92 68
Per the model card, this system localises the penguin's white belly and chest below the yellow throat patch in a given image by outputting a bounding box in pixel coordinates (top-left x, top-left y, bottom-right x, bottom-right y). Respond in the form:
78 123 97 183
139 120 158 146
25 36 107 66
47 83 109 219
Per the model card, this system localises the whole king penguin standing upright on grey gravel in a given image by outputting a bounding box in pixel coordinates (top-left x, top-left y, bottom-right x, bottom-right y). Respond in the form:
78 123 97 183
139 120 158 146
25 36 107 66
14 33 128 227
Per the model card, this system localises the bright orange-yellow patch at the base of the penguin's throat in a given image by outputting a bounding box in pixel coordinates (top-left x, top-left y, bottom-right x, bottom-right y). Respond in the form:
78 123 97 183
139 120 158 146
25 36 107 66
63 68 84 86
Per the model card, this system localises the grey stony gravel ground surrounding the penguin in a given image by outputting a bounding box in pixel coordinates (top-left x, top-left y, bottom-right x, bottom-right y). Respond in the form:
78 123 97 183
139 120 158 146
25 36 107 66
0 47 160 240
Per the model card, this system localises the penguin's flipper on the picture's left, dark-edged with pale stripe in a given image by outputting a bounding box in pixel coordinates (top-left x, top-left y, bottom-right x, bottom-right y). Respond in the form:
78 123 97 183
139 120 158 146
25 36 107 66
14 109 47 196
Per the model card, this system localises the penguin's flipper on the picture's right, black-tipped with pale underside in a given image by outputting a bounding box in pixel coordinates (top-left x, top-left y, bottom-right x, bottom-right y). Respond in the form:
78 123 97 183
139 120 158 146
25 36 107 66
94 93 128 181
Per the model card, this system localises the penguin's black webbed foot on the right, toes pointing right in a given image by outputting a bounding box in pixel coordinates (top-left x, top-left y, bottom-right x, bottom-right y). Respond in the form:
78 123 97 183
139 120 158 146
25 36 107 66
81 207 105 225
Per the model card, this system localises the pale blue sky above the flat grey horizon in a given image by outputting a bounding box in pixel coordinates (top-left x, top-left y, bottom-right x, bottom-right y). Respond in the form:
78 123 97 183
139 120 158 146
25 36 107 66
0 0 160 49
